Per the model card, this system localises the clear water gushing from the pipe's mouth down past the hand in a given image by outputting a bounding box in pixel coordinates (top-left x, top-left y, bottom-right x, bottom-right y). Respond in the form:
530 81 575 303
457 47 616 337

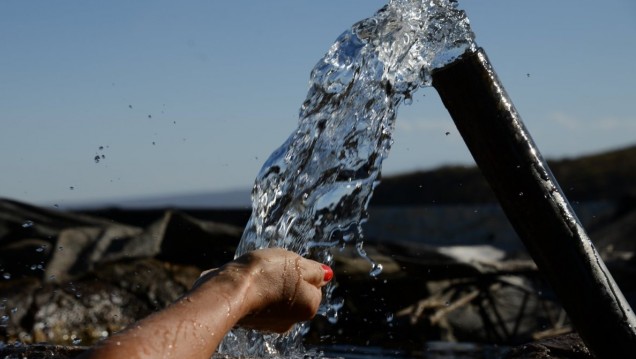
219 0 475 357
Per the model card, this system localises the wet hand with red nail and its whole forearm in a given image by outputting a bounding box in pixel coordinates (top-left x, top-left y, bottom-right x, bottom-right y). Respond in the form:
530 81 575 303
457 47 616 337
78 248 333 359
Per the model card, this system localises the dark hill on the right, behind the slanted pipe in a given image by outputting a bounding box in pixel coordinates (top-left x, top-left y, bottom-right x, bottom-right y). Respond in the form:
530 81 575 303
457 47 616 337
371 146 636 206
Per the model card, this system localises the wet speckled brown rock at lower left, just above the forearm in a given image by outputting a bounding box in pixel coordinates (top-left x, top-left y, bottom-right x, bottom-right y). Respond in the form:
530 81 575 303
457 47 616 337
0 259 200 345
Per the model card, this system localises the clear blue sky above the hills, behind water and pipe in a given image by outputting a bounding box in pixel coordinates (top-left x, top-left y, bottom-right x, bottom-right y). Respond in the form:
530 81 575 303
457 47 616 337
0 0 636 207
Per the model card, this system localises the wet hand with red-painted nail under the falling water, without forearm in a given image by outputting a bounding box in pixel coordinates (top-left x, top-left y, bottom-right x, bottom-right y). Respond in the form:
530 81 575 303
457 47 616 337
195 248 333 333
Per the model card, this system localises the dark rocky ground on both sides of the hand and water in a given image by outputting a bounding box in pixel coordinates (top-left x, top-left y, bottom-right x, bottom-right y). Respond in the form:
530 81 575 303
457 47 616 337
0 200 636 358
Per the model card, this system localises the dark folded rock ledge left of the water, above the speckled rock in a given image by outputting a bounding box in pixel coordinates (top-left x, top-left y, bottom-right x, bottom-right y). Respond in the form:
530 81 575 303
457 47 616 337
0 199 243 283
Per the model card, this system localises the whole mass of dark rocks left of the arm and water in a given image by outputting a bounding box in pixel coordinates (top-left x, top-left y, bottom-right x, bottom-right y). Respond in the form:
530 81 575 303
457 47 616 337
0 200 242 345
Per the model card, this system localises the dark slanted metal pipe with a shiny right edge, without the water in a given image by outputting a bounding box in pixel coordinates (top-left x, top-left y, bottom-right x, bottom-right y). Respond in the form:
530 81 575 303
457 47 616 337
433 49 636 359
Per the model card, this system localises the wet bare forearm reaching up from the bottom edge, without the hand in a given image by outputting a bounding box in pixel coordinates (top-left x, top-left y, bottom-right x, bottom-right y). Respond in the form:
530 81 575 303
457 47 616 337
80 272 248 359
